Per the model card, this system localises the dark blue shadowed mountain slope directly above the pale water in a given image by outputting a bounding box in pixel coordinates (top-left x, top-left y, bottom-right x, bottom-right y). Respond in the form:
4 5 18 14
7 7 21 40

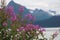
34 16 60 27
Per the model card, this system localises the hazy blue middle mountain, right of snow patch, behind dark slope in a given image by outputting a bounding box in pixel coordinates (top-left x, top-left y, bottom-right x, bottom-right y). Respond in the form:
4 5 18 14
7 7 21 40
32 9 52 21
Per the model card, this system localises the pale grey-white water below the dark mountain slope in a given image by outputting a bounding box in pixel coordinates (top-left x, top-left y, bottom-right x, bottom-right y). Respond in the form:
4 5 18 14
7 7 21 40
41 28 60 40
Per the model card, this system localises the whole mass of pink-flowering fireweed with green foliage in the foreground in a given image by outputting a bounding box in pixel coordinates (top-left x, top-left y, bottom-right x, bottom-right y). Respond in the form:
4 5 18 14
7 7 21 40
0 1 57 40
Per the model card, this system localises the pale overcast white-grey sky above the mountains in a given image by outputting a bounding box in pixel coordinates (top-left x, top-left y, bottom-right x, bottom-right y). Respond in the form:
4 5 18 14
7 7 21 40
0 0 60 14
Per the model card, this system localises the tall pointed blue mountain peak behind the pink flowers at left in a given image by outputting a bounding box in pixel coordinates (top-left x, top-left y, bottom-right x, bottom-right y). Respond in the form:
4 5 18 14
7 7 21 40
7 1 30 15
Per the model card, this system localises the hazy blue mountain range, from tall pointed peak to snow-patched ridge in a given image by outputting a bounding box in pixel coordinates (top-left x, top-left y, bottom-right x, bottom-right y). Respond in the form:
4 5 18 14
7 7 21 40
7 1 52 21
